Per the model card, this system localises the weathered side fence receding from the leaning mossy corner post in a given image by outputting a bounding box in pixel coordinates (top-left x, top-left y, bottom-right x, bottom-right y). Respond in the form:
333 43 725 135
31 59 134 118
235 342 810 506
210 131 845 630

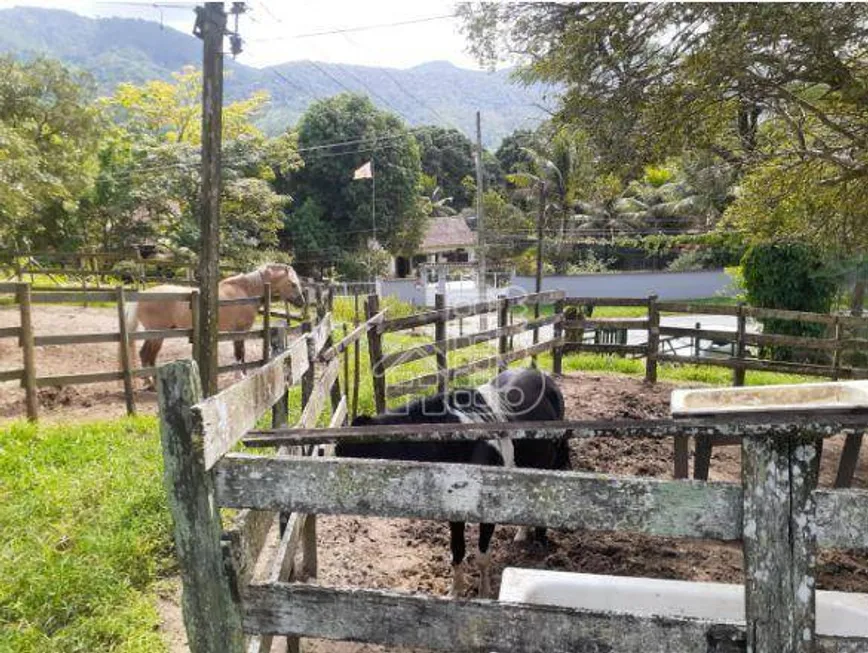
158 313 385 653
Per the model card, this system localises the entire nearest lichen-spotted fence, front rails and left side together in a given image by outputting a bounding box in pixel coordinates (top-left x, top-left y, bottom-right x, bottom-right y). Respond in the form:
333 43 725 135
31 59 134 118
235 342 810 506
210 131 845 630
159 336 868 653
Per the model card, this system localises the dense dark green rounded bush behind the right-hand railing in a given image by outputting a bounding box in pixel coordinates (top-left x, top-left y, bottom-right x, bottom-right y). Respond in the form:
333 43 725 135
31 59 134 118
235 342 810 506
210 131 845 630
742 242 836 362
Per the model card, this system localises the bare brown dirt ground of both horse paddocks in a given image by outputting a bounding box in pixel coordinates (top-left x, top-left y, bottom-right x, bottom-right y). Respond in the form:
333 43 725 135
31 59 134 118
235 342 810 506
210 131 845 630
0 306 868 653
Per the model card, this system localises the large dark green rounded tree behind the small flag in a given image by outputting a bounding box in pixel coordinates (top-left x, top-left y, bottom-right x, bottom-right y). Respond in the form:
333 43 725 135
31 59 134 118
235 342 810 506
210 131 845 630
292 93 425 254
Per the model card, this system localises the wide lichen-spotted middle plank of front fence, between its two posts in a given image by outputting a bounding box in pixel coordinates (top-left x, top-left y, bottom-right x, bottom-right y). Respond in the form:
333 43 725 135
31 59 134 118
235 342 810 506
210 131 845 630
214 453 742 540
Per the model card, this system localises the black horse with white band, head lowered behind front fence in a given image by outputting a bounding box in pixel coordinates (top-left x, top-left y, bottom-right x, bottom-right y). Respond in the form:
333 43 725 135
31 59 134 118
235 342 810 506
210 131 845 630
334 369 570 597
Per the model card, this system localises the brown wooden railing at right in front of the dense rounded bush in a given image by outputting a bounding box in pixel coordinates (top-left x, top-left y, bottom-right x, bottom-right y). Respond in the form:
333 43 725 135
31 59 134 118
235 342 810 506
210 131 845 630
563 295 868 487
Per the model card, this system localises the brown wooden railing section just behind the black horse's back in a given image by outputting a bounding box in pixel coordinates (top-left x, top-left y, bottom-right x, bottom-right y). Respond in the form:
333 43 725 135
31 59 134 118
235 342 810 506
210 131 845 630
366 291 564 412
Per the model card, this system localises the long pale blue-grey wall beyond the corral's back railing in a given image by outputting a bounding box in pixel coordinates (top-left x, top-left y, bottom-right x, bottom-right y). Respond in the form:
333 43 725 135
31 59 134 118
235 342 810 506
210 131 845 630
510 270 736 300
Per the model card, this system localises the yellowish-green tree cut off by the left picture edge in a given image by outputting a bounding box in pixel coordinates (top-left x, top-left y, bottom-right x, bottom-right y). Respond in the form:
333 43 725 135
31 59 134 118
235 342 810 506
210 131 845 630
0 55 99 250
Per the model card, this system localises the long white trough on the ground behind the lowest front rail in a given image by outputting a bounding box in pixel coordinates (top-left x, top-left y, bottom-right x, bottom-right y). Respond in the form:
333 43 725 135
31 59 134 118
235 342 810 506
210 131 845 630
498 567 868 637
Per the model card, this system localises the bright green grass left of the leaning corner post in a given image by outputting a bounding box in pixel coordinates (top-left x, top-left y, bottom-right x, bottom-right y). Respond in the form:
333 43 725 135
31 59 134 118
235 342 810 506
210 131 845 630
0 417 175 653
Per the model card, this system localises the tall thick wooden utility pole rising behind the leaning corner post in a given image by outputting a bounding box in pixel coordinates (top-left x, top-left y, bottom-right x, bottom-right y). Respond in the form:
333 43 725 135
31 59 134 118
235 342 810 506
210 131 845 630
193 2 226 397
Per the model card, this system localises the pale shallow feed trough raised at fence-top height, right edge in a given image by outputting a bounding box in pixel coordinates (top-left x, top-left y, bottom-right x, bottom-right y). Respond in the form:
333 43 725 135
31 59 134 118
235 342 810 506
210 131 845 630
671 381 868 417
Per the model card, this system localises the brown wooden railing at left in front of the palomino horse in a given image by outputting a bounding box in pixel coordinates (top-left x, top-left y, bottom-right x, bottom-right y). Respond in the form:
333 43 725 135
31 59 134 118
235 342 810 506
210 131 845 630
0 283 331 420
